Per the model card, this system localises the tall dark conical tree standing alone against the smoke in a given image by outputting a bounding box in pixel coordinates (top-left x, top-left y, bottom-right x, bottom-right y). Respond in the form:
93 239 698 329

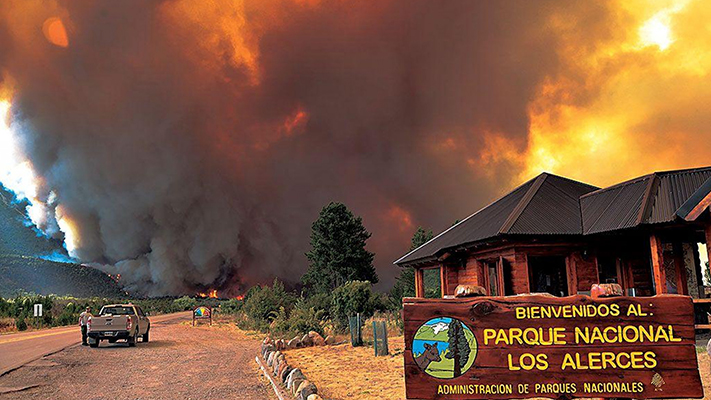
301 202 378 293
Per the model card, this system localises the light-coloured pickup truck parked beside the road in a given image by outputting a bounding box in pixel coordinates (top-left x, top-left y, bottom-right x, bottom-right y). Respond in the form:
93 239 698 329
87 304 151 347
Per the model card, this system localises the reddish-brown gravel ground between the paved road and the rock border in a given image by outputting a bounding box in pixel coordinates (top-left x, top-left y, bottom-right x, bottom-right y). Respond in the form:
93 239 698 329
0 322 276 400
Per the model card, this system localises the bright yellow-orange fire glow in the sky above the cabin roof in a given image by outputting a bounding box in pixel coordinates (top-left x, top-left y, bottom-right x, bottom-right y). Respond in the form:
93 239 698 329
478 1 711 185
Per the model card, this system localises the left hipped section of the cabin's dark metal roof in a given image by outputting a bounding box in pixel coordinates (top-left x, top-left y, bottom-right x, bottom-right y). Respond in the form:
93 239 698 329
395 173 597 264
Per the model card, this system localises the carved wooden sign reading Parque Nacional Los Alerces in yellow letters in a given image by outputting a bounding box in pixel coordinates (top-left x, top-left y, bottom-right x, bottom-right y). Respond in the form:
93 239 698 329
403 295 703 399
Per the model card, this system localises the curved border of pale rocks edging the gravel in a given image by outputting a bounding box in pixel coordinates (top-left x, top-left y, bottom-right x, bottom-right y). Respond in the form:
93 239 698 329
257 331 335 400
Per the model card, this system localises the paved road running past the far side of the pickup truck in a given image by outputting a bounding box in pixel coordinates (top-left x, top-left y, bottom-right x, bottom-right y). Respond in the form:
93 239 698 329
0 311 191 376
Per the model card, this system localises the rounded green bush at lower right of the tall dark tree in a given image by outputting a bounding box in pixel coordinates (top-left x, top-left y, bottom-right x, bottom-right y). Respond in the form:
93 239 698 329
331 281 378 331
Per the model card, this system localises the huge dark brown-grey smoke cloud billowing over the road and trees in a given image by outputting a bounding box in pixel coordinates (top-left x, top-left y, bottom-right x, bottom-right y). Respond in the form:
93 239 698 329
0 1 605 295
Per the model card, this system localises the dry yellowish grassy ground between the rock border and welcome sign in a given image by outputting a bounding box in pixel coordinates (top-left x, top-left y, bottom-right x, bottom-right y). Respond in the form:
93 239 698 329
285 336 711 400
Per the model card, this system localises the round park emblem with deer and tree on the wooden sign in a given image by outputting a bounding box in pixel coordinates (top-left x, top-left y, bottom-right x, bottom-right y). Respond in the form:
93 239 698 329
412 317 477 379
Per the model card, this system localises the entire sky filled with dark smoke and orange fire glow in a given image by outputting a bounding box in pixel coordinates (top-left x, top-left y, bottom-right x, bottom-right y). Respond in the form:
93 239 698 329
0 0 711 295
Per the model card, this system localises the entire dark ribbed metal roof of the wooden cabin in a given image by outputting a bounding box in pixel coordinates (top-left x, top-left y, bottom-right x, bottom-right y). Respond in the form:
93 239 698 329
395 167 711 265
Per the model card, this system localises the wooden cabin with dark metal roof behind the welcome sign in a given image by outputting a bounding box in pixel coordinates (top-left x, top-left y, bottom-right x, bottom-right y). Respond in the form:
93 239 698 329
395 167 711 327
